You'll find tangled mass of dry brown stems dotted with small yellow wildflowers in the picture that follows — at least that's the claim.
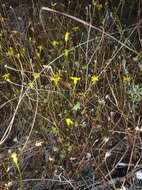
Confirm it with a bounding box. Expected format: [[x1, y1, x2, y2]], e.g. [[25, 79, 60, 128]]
[[0, 0, 142, 189]]
